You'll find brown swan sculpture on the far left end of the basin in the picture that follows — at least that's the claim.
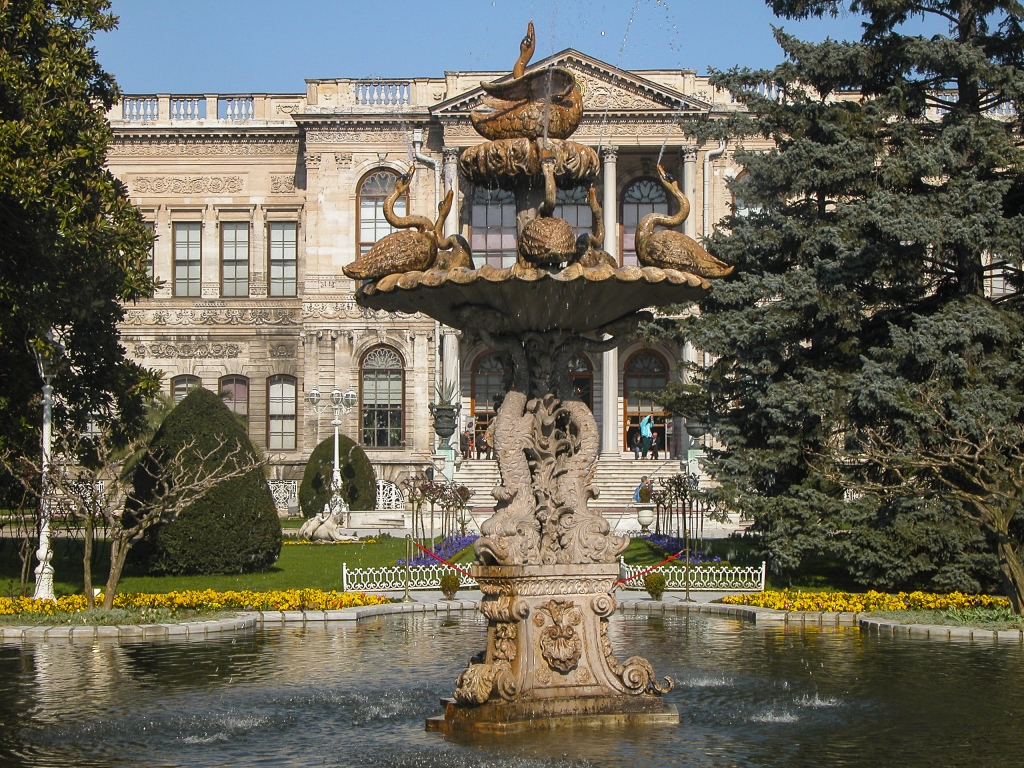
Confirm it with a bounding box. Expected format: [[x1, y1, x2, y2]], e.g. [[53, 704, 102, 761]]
[[341, 164, 437, 280]]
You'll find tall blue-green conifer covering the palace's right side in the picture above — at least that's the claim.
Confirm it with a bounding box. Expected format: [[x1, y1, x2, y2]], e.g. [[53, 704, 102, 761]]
[[664, 0, 1024, 604]]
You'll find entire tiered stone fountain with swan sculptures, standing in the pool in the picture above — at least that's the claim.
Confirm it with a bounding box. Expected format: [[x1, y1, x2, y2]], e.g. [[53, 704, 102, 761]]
[[345, 24, 730, 731]]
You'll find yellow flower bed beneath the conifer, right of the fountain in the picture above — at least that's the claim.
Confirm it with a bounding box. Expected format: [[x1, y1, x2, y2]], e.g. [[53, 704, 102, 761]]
[[722, 590, 1010, 613]]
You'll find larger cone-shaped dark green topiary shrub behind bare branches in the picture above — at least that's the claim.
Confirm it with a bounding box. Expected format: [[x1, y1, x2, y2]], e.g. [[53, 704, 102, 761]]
[[134, 388, 281, 574]]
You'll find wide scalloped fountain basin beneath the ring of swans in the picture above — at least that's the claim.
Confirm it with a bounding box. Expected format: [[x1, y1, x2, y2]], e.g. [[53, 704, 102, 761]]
[[355, 264, 711, 333]]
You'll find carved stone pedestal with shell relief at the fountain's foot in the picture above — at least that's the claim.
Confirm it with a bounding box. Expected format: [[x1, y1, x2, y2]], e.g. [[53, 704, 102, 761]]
[[427, 563, 679, 731]]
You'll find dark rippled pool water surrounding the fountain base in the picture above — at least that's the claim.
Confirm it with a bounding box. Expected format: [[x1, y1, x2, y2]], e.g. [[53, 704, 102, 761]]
[[0, 613, 1024, 768]]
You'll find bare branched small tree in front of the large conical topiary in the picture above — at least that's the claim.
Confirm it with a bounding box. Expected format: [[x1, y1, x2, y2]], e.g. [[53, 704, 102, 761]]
[[0, 429, 264, 610]]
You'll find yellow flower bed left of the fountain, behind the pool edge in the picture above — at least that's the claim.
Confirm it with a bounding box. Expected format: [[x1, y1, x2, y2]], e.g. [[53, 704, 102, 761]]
[[0, 590, 390, 615]]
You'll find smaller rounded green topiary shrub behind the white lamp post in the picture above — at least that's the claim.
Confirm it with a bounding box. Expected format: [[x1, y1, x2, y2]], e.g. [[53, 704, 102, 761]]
[[299, 434, 377, 517]]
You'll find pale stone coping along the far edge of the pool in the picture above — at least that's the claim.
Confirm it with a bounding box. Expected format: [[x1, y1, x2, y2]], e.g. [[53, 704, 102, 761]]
[[0, 599, 1024, 645]]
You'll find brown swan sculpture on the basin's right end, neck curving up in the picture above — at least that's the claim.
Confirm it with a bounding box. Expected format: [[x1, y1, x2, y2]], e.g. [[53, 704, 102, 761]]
[[636, 166, 735, 278]]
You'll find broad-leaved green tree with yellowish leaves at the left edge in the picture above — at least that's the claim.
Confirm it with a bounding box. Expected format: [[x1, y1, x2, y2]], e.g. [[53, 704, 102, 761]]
[[0, 0, 157, 453]]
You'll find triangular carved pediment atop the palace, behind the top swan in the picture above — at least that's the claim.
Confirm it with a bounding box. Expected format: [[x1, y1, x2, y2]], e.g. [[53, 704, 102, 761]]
[[430, 48, 711, 119]]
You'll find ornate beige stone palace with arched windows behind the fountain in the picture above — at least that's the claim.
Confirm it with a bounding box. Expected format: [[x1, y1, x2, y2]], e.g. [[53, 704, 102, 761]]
[[110, 50, 761, 506]]
